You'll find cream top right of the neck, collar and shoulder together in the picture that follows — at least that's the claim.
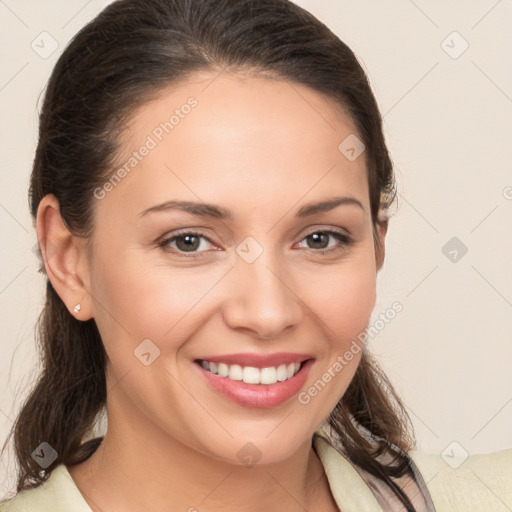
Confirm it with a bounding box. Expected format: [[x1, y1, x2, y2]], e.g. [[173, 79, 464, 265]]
[[313, 431, 512, 512]]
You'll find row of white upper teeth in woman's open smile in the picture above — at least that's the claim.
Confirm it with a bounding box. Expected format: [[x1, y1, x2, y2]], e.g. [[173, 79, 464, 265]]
[[201, 360, 300, 385]]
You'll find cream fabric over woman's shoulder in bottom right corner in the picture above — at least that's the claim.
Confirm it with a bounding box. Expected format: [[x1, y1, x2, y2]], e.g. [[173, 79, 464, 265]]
[[409, 449, 512, 512]]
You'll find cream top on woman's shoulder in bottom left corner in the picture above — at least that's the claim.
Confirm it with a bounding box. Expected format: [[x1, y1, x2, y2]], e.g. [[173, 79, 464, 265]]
[[0, 464, 91, 512]]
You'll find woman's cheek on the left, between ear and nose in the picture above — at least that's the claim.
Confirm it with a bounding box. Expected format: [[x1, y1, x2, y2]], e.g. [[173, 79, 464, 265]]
[[91, 243, 226, 348]]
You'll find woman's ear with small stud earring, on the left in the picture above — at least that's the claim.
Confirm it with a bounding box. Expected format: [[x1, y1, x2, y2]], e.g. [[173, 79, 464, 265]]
[[36, 194, 92, 320]]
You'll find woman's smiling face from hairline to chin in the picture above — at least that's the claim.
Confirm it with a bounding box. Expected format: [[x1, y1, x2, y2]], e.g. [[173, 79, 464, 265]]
[[89, 72, 378, 464]]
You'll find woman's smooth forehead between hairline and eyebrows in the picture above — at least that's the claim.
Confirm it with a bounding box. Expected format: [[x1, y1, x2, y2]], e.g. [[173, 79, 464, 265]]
[[98, 72, 368, 222]]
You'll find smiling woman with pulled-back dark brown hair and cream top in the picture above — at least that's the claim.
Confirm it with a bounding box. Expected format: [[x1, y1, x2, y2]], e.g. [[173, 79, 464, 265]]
[[2, 0, 508, 512]]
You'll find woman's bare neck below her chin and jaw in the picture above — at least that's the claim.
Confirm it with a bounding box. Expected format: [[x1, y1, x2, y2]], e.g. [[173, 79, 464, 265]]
[[69, 394, 332, 512]]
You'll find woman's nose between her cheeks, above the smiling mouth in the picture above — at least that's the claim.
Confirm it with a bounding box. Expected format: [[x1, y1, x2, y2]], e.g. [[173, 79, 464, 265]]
[[223, 253, 303, 340]]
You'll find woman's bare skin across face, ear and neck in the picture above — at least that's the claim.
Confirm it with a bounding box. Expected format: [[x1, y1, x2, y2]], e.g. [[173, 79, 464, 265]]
[[37, 71, 385, 512]]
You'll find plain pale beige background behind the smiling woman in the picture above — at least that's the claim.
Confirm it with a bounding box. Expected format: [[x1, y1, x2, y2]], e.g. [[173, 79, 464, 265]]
[[0, 0, 512, 496]]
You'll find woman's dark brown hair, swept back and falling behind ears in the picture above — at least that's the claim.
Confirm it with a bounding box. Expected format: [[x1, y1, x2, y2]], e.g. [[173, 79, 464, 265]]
[[4, 0, 414, 511]]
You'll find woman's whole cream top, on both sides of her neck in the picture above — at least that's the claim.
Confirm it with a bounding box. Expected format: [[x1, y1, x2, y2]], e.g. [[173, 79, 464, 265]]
[[0, 431, 512, 512]]
